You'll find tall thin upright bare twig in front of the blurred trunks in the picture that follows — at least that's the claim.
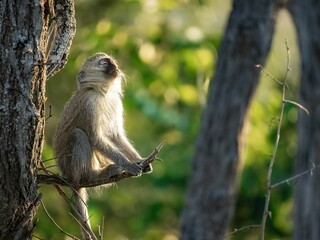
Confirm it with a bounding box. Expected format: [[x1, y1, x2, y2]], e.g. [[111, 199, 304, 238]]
[[260, 39, 290, 240]]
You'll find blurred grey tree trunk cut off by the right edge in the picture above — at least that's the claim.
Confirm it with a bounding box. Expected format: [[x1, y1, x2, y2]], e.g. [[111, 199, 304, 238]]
[[289, 0, 320, 240]]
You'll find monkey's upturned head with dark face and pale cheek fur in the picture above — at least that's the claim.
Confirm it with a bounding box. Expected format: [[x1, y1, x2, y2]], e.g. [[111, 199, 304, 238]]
[[77, 53, 123, 91]]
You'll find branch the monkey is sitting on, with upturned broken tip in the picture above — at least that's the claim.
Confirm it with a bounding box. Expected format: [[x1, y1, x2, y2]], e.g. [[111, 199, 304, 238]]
[[37, 142, 164, 188]]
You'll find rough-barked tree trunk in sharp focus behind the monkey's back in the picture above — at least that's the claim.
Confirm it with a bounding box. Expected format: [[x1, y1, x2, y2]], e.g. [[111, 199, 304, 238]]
[[0, 0, 73, 239]]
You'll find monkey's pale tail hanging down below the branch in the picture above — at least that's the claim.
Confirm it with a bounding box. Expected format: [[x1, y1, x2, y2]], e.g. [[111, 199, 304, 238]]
[[73, 188, 92, 240]]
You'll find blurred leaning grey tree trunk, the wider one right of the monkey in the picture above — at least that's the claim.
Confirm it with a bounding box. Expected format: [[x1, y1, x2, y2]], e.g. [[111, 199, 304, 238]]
[[181, 0, 279, 240]]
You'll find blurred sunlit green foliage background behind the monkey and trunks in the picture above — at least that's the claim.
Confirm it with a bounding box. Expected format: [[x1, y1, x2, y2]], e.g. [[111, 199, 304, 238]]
[[35, 0, 299, 240]]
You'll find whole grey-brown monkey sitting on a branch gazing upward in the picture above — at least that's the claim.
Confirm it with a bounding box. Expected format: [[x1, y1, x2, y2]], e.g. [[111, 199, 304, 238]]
[[53, 53, 152, 239]]
